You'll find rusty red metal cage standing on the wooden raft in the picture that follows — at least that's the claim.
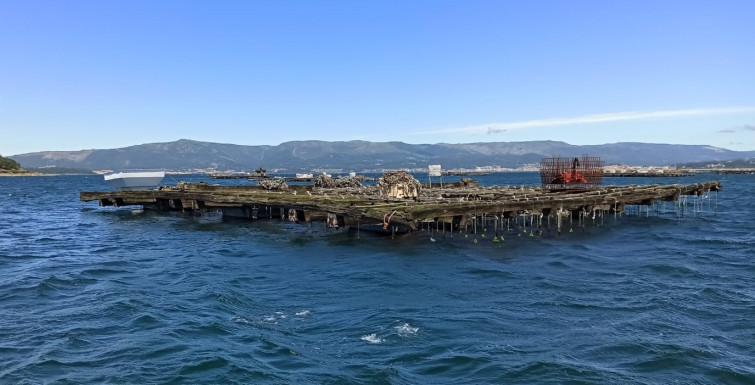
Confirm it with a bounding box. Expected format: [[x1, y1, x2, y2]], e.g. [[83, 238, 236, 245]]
[[540, 155, 603, 189]]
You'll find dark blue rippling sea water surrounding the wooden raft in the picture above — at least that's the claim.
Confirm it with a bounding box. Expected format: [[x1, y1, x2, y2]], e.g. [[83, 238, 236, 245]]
[[0, 173, 755, 384]]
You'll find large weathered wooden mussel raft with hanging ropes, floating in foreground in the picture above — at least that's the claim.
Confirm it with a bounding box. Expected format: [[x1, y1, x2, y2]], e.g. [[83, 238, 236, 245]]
[[80, 181, 722, 231]]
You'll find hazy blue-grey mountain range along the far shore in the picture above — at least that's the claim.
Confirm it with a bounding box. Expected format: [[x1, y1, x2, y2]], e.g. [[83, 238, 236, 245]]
[[10, 139, 755, 172]]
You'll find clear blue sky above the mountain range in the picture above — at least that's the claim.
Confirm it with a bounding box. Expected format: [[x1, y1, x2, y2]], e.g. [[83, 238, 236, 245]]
[[0, 0, 755, 155]]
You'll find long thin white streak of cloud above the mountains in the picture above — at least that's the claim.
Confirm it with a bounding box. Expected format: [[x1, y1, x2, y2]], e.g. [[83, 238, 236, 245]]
[[417, 107, 755, 134]]
